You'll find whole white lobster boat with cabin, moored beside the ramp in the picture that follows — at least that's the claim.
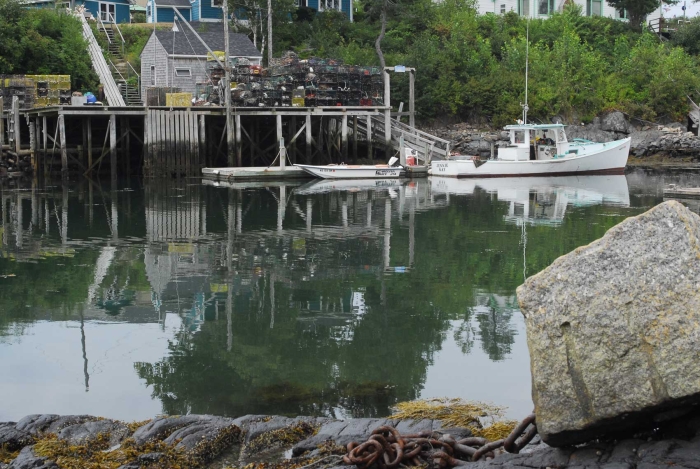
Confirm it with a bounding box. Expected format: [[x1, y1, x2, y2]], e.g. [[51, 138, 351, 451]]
[[429, 124, 631, 178]]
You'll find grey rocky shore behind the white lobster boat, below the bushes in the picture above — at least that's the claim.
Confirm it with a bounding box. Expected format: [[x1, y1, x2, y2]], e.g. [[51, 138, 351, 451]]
[[424, 112, 700, 162]]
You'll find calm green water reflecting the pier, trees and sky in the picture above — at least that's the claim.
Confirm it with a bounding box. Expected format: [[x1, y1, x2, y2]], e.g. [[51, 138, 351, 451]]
[[0, 171, 700, 421]]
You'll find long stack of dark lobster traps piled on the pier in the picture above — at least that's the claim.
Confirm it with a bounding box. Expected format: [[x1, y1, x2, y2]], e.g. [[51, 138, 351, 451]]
[[198, 52, 384, 107]]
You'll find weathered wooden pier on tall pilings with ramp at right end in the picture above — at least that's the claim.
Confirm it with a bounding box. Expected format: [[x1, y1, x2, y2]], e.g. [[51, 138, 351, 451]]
[[0, 98, 449, 178]]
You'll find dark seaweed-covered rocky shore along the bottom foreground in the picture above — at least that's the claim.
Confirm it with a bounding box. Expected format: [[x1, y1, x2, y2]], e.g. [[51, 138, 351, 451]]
[[0, 412, 700, 469]]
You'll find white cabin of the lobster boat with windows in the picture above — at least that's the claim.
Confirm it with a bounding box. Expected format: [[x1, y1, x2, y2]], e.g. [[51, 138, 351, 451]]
[[498, 124, 577, 161]]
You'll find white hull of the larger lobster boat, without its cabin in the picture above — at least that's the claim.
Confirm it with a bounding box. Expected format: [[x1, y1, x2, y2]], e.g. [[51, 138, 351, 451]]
[[430, 138, 631, 178]]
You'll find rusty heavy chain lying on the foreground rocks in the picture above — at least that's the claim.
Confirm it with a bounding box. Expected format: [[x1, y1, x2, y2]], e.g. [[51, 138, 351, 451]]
[[343, 414, 537, 469]]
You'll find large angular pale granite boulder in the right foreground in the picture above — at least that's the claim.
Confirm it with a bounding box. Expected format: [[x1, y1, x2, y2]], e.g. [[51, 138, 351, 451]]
[[517, 202, 700, 444]]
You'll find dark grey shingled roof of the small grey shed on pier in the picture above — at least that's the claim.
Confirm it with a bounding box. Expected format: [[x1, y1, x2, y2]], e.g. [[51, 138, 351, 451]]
[[154, 23, 262, 57]]
